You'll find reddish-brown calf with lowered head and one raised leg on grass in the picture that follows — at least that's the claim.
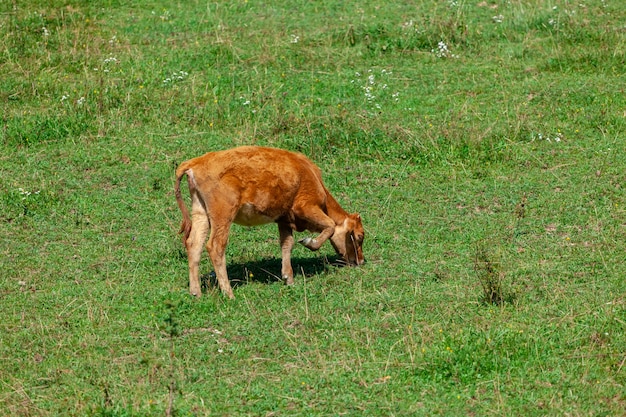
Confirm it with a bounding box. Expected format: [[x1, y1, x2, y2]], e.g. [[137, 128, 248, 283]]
[[174, 146, 365, 298]]
